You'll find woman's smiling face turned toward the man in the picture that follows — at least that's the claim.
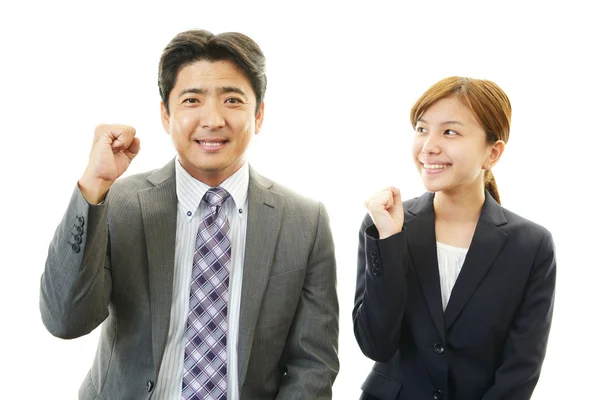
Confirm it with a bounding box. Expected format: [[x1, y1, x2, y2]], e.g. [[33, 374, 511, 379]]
[[412, 97, 503, 193]]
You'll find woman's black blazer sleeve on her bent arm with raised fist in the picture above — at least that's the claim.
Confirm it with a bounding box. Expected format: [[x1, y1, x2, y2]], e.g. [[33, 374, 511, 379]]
[[352, 215, 408, 362]]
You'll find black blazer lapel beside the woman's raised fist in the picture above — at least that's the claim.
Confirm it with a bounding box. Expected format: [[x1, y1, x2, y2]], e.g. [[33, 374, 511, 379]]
[[404, 192, 446, 341]]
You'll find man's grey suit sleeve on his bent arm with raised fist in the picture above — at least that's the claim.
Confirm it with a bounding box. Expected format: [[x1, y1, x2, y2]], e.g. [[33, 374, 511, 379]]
[[40, 186, 112, 339]]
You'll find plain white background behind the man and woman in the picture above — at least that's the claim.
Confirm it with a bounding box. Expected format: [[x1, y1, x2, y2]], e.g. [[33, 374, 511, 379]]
[[0, 0, 600, 400]]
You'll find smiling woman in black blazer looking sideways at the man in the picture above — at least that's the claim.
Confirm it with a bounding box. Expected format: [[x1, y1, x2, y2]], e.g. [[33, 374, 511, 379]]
[[353, 77, 556, 400]]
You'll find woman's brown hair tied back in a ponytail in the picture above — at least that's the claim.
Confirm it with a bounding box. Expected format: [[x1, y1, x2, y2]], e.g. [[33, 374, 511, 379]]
[[410, 76, 512, 204]]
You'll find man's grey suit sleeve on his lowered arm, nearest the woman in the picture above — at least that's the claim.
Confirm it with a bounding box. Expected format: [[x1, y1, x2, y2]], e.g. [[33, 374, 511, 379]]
[[277, 204, 339, 400]]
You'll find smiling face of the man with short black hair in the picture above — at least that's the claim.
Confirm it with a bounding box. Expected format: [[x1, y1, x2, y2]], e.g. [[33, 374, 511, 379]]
[[161, 61, 264, 186]]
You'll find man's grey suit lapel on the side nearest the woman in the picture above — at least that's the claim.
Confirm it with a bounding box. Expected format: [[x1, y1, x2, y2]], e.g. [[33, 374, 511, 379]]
[[238, 168, 283, 386]]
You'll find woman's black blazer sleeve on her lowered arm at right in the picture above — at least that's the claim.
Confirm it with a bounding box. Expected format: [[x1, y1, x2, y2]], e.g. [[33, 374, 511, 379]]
[[483, 232, 556, 400]]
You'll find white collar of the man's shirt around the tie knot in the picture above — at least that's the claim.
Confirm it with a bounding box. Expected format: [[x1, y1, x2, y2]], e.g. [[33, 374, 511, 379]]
[[175, 159, 250, 219]]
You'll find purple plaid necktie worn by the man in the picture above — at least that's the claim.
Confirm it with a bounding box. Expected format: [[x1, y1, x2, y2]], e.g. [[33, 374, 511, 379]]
[[182, 186, 231, 400]]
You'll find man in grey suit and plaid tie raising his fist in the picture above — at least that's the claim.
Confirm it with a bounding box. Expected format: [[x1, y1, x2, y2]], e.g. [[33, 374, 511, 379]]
[[40, 30, 339, 400]]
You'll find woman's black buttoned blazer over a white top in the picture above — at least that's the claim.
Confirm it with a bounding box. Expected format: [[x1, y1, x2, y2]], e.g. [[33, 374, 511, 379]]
[[352, 192, 556, 400]]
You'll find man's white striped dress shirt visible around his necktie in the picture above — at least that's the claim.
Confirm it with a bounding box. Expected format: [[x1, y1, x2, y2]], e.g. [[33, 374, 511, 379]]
[[153, 162, 250, 400]]
